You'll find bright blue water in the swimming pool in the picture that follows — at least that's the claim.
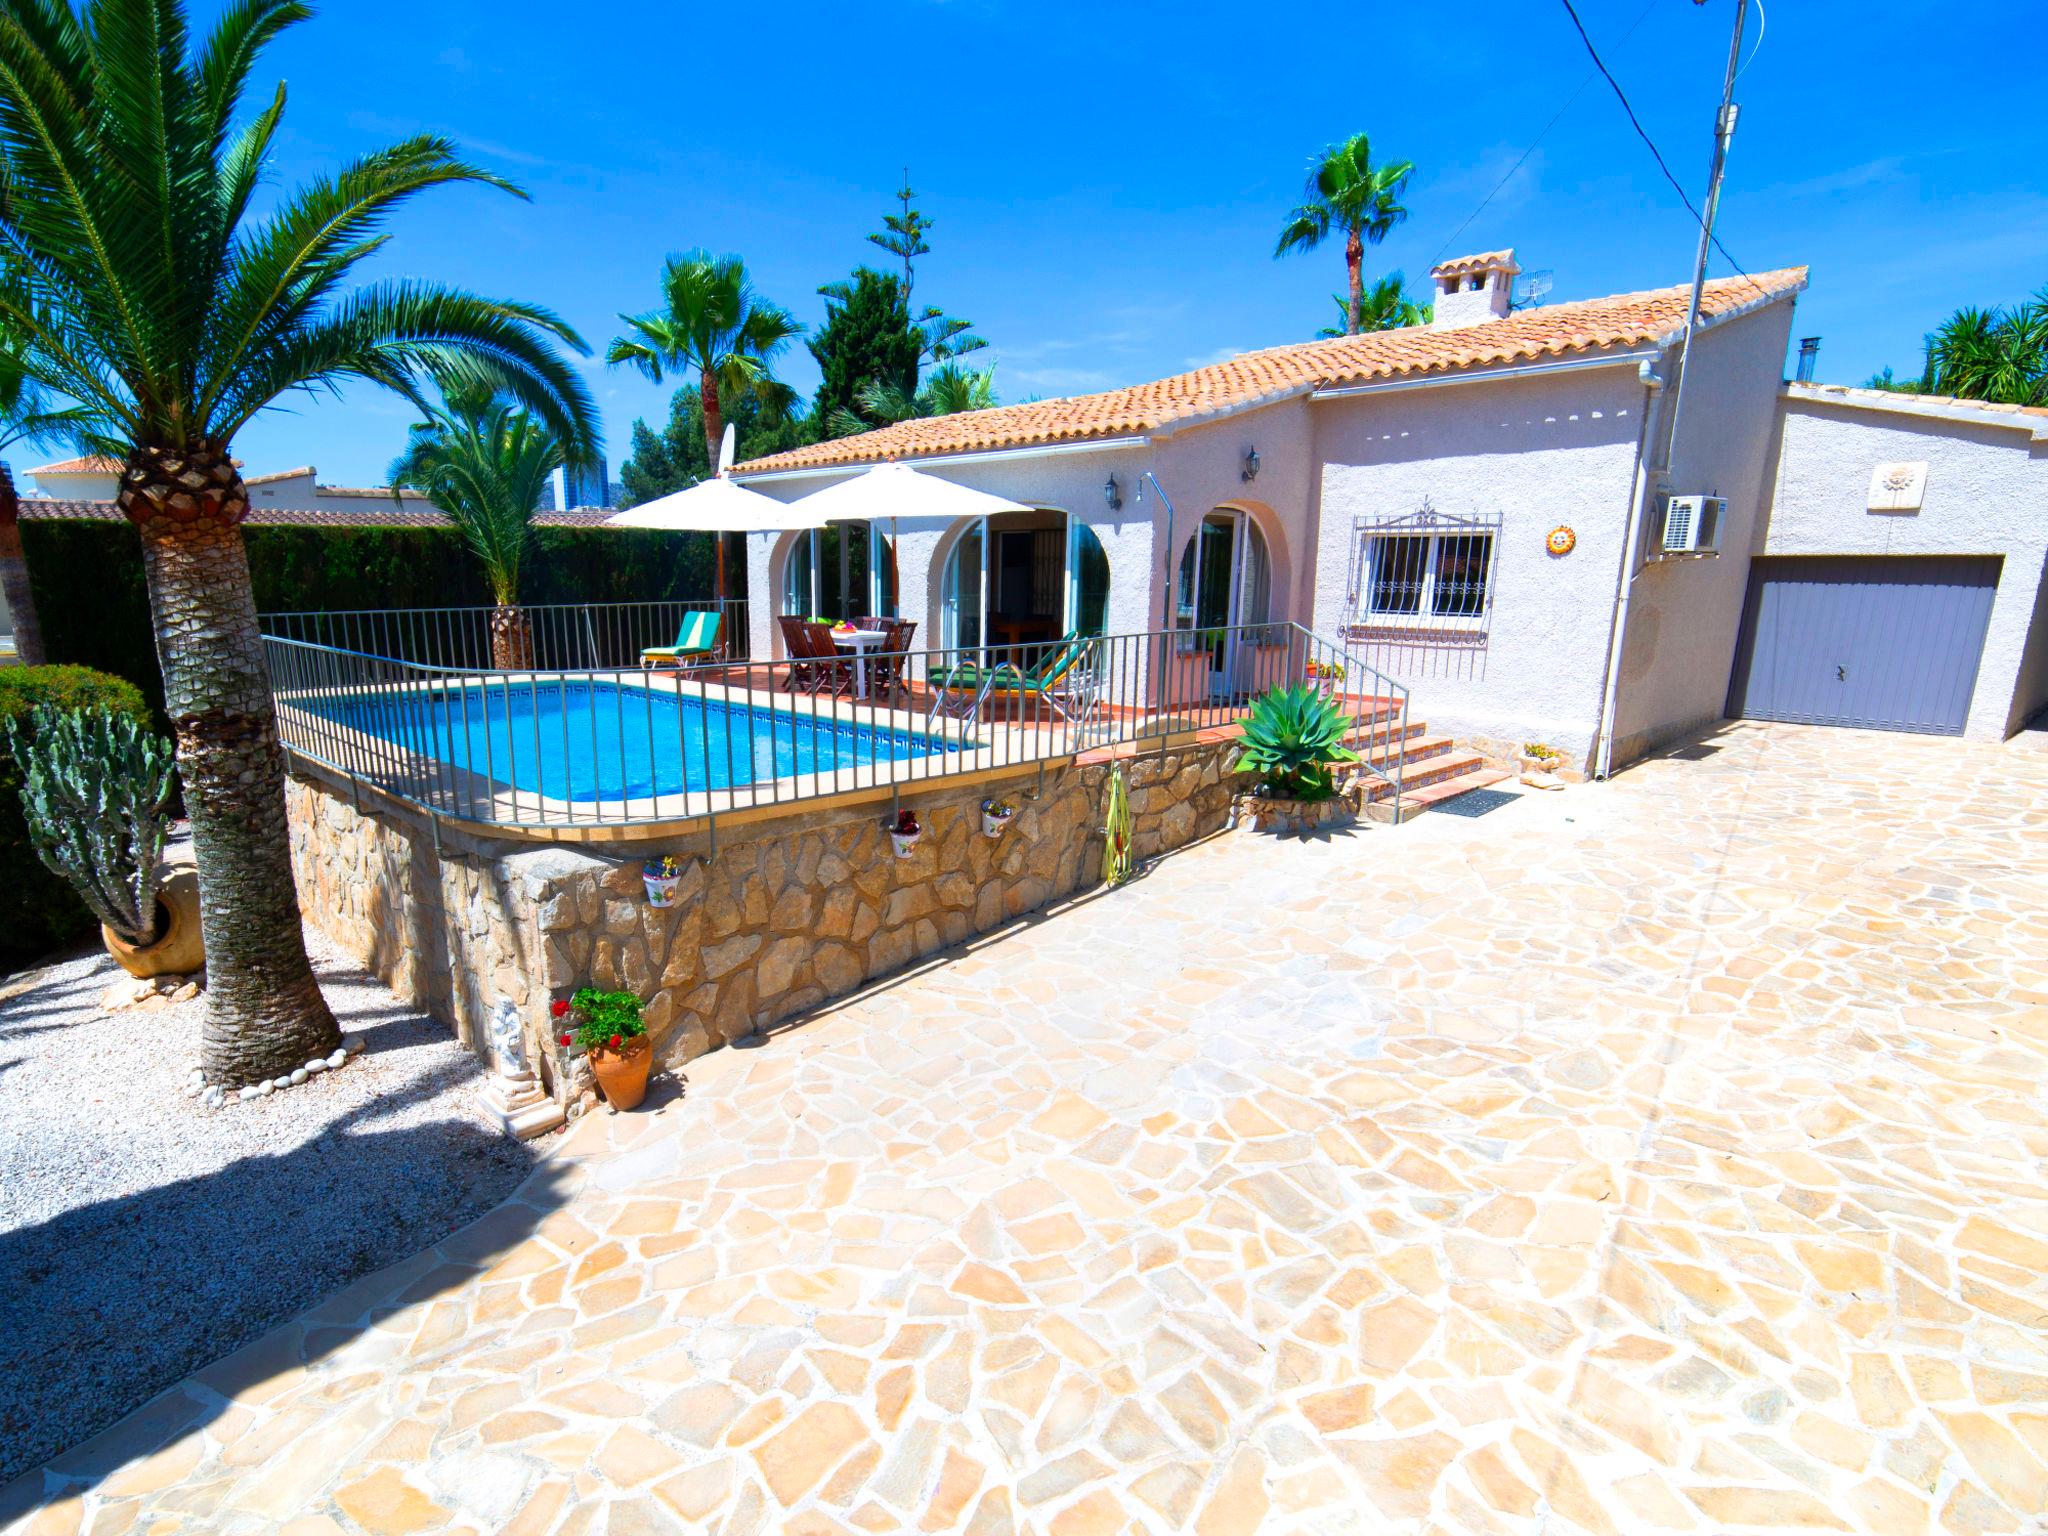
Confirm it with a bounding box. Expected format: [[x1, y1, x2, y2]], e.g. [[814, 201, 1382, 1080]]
[[299, 678, 971, 801]]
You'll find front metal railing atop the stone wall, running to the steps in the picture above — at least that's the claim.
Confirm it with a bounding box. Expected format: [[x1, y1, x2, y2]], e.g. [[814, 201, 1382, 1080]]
[[264, 610, 1407, 829]]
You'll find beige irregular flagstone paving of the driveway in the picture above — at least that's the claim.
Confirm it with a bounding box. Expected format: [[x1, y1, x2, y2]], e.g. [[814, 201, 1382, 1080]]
[[4, 727, 2048, 1536]]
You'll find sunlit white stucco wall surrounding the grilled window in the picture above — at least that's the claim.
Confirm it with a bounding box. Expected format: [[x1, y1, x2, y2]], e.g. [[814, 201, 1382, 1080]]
[[1311, 362, 1647, 760]]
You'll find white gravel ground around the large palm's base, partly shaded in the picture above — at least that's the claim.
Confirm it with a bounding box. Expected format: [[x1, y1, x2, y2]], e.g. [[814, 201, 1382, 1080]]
[[0, 932, 547, 1483]]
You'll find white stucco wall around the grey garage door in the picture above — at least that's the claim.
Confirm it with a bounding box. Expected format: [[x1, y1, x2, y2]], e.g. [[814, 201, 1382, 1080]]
[[1757, 385, 2048, 741]]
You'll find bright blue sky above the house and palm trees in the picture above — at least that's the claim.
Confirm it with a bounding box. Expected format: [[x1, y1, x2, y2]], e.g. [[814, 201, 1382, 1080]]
[[228, 0, 2048, 483]]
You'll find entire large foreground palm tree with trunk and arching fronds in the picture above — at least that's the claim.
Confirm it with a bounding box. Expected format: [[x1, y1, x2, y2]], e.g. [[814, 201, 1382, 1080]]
[[0, 0, 596, 1083]]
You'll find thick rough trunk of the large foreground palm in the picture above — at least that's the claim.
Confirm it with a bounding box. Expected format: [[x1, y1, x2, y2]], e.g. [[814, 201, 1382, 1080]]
[[119, 449, 340, 1085]]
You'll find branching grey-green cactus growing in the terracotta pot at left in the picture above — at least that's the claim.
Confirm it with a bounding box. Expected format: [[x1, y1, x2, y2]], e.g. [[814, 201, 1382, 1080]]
[[6, 705, 176, 944]]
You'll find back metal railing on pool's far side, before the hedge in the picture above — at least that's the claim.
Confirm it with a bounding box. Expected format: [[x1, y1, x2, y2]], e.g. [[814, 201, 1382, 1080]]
[[262, 598, 748, 672]]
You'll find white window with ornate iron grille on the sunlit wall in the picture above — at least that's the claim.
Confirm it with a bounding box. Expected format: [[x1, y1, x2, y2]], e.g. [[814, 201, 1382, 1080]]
[[1352, 502, 1501, 643]]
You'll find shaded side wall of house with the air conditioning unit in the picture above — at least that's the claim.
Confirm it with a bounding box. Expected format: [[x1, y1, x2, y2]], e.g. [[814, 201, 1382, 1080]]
[[1614, 303, 1792, 764]]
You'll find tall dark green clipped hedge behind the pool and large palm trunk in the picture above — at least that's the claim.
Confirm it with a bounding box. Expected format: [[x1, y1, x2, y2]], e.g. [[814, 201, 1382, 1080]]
[[20, 522, 729, 715]]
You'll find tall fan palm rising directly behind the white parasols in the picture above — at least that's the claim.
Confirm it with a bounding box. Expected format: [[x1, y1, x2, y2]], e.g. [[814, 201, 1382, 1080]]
[[604, 250, 803, 598]]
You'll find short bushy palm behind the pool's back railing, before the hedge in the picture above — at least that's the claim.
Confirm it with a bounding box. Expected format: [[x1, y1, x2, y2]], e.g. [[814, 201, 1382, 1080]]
[[391, 387, 569, 672]]
